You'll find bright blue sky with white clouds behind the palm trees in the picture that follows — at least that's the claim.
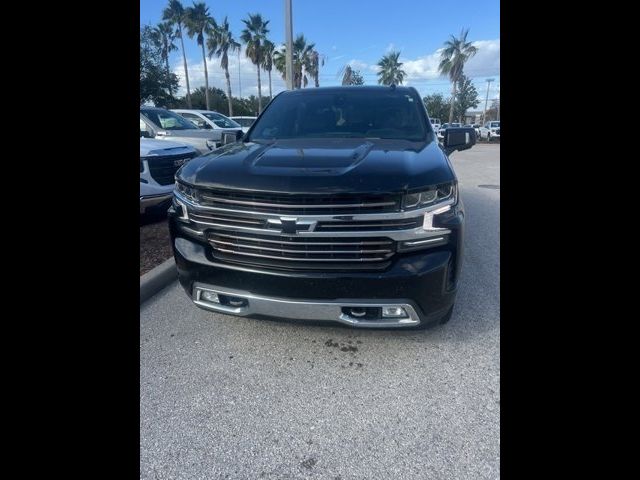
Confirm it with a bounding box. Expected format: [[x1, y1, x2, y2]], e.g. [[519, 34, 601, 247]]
[[140, 0, 500, 109]]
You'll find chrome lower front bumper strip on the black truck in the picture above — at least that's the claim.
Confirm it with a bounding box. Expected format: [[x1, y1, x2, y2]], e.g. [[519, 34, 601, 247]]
[[192, 282, 421, 328]]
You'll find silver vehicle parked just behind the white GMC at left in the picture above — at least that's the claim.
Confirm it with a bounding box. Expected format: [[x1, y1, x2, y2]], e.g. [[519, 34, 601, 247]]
[[140, 107, 222, 154]]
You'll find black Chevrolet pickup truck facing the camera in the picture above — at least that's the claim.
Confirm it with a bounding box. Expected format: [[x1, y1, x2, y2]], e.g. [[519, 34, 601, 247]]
[[169, 86, 476, 328]]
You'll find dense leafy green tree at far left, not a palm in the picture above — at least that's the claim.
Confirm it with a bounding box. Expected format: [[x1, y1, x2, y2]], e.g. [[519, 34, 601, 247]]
[[140, 25, 178, 107]]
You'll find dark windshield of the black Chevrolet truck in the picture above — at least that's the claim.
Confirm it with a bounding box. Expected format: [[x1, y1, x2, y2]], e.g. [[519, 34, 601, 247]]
[[250, 89, 430, 141]]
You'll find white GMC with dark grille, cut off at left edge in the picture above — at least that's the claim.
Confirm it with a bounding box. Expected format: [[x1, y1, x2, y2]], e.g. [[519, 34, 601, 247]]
[[140, 138, 198, 213]]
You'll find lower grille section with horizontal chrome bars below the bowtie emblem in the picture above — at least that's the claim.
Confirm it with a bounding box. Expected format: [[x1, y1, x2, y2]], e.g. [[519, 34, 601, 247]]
[[207, 230, 395, 265]]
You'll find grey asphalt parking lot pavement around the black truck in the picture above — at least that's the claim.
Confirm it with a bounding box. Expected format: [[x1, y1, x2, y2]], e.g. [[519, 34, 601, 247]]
[[140, 144, 500, 480]]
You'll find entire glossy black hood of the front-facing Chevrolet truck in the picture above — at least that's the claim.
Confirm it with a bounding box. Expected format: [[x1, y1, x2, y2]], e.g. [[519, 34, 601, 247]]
[[180, 139, 455, 194]]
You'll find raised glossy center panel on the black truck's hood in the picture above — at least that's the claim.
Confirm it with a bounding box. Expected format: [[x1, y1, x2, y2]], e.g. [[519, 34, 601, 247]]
[[250, 142, 373, 176]]
